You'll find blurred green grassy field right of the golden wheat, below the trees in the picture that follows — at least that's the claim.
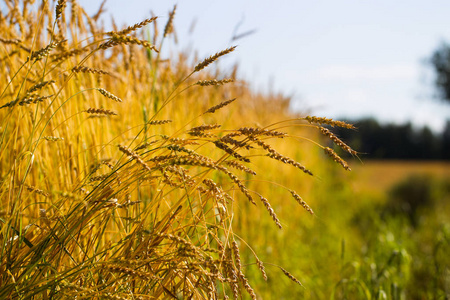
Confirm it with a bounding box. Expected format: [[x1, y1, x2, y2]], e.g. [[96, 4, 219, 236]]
[[229, 160, 450, 299]]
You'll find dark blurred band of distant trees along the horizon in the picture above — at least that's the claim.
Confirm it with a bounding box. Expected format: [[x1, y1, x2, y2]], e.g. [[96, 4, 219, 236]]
[[332, 119, 450, 160]]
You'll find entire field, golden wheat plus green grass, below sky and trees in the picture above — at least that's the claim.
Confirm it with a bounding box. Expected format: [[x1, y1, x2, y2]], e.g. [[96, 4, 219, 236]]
[[0, 0, 450, 299]]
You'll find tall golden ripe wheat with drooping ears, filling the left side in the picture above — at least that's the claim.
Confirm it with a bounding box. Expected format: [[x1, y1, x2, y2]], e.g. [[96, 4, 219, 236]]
[[0, 0, 356, 299]]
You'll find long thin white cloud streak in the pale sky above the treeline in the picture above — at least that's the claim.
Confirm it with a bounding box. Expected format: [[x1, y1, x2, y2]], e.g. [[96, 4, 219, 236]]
[[314, 64, 419, 81]]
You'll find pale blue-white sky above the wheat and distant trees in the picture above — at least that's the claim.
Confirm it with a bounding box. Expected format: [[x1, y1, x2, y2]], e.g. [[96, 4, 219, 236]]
[[79, 0, 450, 131]]
